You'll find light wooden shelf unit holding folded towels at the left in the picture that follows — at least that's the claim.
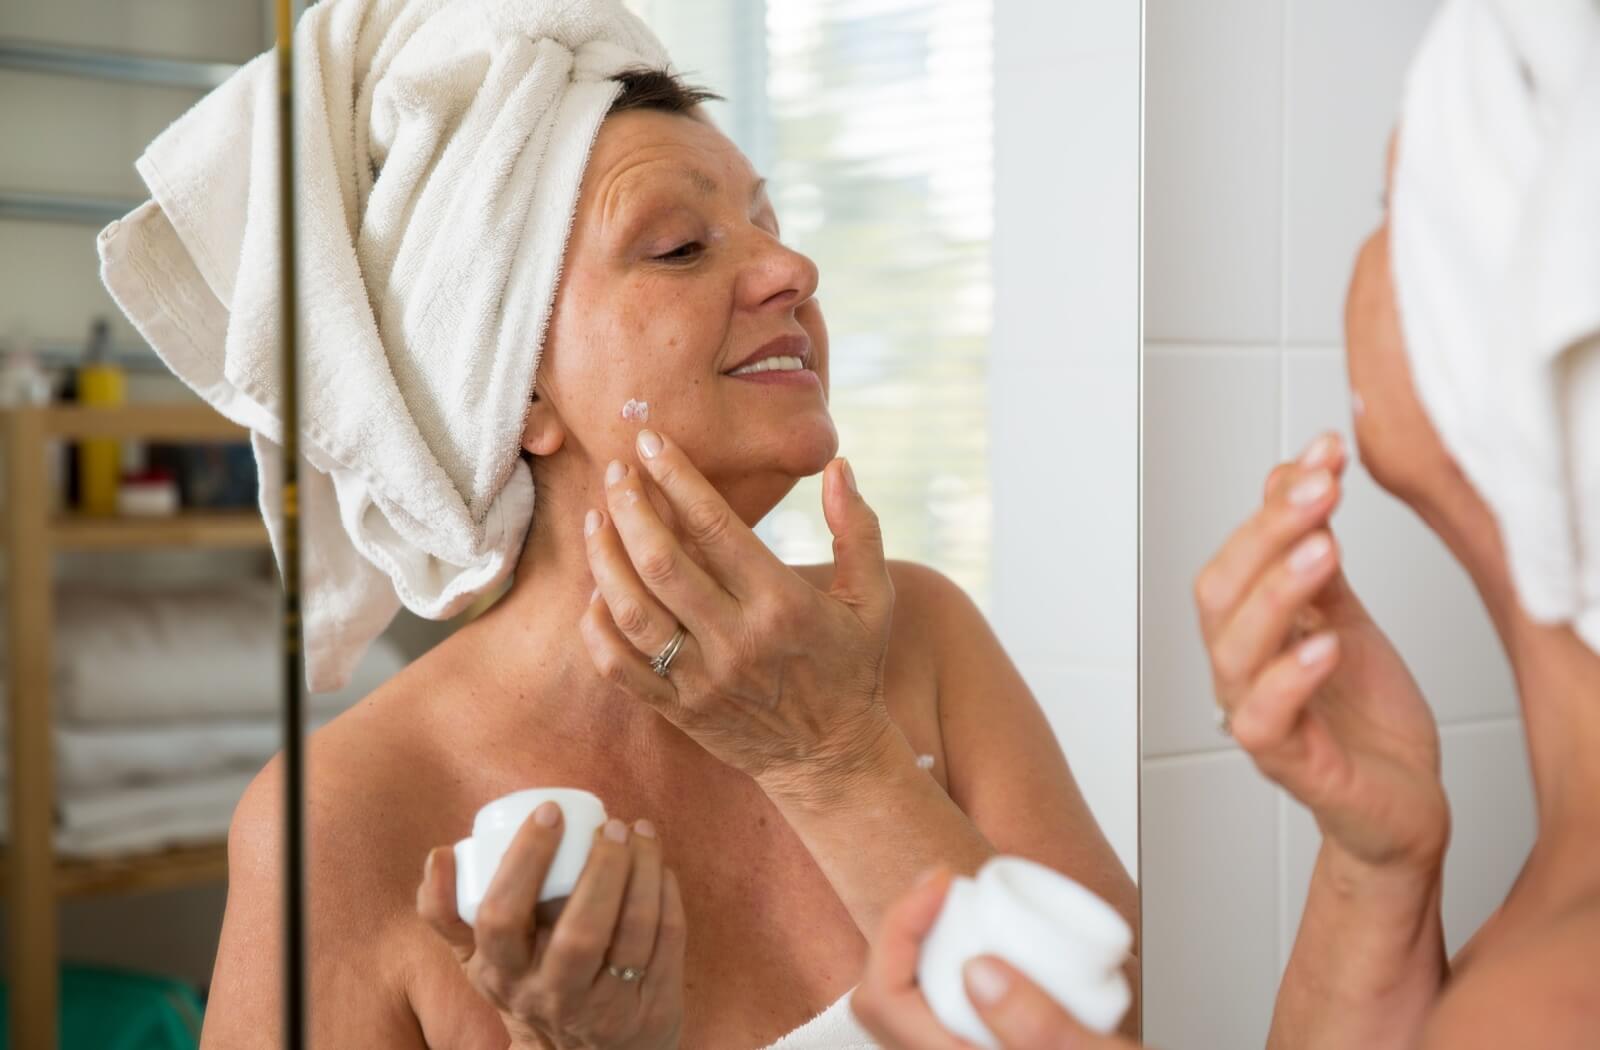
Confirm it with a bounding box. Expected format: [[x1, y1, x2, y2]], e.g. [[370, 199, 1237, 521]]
[[0, 403, 267, 1047]]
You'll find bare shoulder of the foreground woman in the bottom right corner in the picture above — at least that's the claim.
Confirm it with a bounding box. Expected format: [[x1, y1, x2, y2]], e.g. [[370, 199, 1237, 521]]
[[1422, 896, 1600, 1050]]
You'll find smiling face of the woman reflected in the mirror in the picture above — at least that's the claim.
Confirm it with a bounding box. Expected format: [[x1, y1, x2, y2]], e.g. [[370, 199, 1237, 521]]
[[534, 110, 838, 520]]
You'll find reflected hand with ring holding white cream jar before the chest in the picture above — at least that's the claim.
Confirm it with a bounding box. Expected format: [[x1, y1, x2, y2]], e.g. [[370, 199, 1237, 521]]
[[418, 802, 685, 1050]]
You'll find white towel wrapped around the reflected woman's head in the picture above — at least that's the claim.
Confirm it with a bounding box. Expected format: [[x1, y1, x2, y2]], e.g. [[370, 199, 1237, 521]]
[[99, 0, 667, 691]]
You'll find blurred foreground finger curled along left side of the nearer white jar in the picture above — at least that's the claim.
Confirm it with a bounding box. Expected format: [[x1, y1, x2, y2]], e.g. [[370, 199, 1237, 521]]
[[850, 868, 966, 1050]]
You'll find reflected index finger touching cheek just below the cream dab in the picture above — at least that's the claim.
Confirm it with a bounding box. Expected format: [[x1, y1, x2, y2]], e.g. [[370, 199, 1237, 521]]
[[629, 431, 778, 605]]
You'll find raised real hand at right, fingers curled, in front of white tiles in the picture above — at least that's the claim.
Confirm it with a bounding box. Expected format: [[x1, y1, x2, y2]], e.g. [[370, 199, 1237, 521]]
[[1195, 434, 1450, 874]]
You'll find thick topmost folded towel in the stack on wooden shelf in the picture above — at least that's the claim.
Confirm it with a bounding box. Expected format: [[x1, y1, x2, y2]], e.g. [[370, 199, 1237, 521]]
[[3, 581, 406, 727]]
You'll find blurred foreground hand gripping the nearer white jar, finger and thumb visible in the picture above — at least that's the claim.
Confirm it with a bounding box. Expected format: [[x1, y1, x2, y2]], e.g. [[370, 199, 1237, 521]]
[[850, 871, 1134, 1050]]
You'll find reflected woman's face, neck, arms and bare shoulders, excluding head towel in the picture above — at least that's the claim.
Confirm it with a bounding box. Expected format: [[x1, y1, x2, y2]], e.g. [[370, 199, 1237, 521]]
[[152, 8, 1133, 1050]]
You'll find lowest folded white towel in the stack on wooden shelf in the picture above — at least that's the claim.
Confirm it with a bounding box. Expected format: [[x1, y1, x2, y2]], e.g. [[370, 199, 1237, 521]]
[[0, 773, 254, 856]]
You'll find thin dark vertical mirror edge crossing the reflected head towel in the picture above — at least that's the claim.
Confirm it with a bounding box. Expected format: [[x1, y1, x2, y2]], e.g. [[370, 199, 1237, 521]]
[[268, 0, 307, 1050]]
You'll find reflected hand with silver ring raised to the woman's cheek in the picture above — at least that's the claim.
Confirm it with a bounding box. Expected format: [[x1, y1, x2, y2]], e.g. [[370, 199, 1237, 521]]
[[582, 431, 894, 802]]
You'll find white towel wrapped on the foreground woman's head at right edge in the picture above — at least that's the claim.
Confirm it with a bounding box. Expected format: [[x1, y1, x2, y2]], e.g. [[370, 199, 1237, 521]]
[[1390, 0, 1600, 650]]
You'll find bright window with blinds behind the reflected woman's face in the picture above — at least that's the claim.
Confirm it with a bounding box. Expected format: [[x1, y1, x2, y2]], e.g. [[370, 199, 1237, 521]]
[[629, 0, 994, 603]]
